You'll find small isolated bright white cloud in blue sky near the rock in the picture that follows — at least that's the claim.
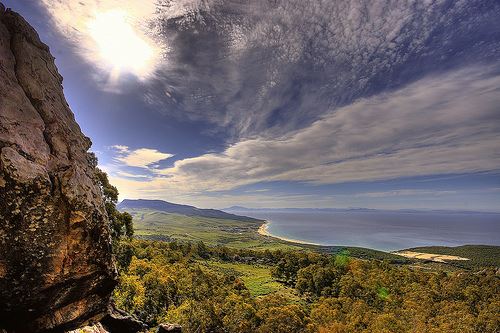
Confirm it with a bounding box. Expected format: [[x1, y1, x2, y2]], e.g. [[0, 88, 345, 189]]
[[112, 145, 174, 167]]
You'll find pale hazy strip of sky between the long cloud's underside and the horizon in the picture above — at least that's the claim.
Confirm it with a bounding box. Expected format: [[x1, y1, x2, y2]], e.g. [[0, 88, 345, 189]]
[[100, 177, 498, 211]]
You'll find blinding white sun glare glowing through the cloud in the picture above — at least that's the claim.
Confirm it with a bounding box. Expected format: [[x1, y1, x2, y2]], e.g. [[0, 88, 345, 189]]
[[88, 10, 156, 77]]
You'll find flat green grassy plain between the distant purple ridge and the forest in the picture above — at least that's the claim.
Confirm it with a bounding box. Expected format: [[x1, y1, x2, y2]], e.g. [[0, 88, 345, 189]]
[[127, 209, 300, 250]]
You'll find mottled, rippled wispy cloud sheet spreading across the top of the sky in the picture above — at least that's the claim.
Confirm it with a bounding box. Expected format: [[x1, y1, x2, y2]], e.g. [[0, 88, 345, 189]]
[[42, 0, 500, 135]]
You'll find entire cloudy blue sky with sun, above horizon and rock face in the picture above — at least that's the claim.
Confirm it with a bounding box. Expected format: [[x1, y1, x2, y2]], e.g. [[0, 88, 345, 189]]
[[3, 0, 500, 211]]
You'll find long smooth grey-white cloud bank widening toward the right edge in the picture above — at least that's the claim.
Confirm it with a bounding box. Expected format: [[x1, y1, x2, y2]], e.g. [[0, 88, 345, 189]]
[[108, 68, 500, 196]]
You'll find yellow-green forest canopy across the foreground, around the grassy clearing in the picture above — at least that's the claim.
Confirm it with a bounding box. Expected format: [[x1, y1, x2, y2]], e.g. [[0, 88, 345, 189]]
[[114, 240, 500, 333]]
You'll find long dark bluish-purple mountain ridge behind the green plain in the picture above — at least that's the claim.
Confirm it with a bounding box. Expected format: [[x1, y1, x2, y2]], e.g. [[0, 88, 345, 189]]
[[117, 199, 261, 222]]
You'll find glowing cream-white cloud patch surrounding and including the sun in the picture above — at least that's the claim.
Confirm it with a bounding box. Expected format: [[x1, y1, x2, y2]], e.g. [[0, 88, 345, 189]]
[[41, 0, 218, 81]]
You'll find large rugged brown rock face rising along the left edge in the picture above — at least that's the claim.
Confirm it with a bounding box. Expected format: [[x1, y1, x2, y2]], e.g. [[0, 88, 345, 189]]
[[0, 6, 116, 333]]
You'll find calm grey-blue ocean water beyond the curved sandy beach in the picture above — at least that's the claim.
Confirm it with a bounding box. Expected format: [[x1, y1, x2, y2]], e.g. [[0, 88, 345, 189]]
[[233, 210, 500, 251]]
